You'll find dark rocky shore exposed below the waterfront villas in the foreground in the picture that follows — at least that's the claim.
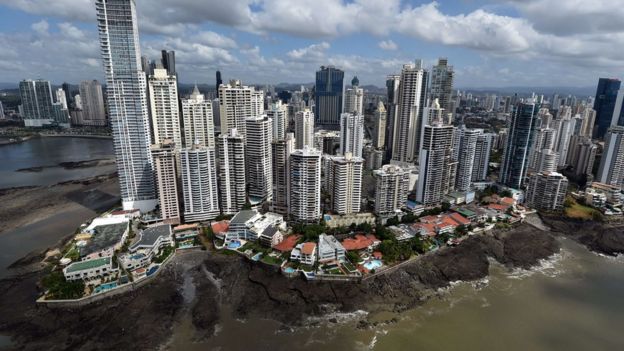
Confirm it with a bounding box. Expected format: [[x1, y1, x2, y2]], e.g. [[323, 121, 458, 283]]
[[0, 224, 559, 350]]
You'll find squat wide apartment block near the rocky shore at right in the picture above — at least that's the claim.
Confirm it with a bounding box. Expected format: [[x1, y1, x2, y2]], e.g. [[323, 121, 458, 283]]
[[526, 172, 568, 211]]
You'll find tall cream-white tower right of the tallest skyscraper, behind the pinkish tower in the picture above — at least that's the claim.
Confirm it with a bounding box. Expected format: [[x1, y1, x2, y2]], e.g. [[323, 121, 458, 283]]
[[147, 68, 182, 148]]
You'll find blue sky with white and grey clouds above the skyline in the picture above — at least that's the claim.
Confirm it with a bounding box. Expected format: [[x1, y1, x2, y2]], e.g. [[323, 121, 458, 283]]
[[0, 0, 624, 88]]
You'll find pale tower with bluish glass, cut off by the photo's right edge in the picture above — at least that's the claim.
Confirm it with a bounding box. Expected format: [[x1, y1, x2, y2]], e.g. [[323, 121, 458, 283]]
[[596, 126, 624, 188]]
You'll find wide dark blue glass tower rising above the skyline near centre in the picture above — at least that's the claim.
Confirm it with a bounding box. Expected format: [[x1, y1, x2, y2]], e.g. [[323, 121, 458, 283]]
[[314, 66, 344, 127]]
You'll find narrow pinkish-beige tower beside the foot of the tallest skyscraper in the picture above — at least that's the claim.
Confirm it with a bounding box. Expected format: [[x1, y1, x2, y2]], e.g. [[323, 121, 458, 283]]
[[151, 139, 180, 224]]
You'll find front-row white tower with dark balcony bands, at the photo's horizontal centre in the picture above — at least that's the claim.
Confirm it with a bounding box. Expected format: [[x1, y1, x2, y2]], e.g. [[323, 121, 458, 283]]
[[288, 146, 321, 223]]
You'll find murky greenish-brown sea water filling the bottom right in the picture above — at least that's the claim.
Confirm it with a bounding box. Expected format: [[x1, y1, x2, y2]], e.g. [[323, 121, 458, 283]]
[[169, 239, 624, 351]]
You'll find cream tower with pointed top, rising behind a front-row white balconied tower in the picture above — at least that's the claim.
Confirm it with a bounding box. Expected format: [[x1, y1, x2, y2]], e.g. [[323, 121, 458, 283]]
[[182, 85, 215, 149]]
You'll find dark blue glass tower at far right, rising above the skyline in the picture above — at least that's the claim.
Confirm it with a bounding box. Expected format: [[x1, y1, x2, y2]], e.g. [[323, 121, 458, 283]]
[[594, 78, 621, 139]]
